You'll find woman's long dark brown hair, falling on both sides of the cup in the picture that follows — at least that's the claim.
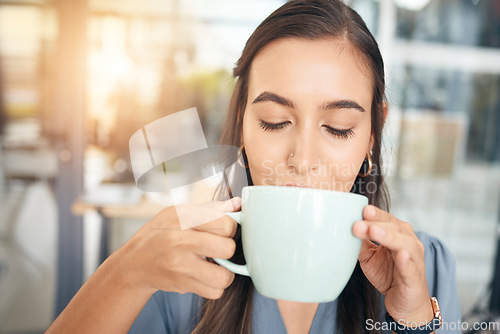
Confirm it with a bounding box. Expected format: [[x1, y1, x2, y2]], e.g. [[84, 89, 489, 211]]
[[193, 0, 389, 334]]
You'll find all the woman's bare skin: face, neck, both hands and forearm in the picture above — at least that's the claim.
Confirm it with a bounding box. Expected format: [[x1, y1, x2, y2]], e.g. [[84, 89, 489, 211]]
[[47, 39, 432, 333]]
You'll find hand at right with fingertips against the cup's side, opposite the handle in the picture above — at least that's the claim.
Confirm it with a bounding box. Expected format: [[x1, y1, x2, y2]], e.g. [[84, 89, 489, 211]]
[[352, 205, 433, 325]]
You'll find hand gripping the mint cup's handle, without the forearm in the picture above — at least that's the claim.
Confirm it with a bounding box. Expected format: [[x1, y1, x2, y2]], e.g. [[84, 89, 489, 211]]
[[108, 197, 241, 299]]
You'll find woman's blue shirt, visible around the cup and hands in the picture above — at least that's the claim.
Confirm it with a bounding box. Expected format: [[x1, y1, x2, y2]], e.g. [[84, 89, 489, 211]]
[[129, 232, 461, 334]]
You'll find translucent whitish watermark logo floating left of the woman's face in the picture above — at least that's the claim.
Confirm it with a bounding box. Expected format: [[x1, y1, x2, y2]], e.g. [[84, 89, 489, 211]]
[[129, 108, 248, 229]]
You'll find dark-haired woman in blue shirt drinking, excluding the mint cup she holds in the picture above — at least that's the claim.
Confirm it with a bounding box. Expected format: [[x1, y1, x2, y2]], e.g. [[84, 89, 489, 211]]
[[49, 0, 460, 333]]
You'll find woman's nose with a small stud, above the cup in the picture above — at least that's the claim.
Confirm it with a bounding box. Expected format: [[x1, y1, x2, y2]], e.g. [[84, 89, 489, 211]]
[[288, 125, 321, 176]]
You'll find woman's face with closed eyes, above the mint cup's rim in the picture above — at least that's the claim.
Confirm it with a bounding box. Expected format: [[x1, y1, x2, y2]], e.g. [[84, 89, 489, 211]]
[[242, 38, 373, 191]]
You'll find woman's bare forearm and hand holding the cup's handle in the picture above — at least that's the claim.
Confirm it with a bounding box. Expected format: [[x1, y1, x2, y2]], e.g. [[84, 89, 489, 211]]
[[46, 198, 241, 334]]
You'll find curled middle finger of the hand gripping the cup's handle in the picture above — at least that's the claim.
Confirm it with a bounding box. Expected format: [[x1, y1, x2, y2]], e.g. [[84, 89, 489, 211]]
[[189, 232, 236, 259]]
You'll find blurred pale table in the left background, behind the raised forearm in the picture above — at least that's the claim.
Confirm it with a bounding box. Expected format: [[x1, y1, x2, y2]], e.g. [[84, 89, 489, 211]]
[[71, 184, 168, 264]]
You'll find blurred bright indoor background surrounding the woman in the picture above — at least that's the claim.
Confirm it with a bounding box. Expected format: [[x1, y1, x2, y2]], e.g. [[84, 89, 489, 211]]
[[0, 0, 500, 333]]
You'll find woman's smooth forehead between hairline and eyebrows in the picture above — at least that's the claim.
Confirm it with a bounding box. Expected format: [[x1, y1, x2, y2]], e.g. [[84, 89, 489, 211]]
[[249, 38, 373, 99]]
